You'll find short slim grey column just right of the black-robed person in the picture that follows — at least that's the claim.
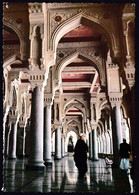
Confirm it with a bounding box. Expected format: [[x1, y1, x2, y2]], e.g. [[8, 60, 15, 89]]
[[92, 129, 98, 161]]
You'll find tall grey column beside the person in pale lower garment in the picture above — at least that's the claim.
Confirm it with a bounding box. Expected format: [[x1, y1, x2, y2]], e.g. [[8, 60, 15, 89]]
[[112, 105, 122, 167]]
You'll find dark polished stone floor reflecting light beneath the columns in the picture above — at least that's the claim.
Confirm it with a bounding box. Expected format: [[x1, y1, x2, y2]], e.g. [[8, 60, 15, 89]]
[[1, 156, 135, 193]]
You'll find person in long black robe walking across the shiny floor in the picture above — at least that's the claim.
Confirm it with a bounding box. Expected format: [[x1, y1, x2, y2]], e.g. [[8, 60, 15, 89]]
[[74, 133, 88, 179]]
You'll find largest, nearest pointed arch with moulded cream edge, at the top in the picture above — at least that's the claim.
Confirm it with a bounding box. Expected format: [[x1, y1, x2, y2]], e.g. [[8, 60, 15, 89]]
[[50, 13, 117, 54]]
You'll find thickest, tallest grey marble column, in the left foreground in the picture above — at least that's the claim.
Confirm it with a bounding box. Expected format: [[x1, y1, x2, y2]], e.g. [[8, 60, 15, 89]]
[[26, 86, 45, 170]]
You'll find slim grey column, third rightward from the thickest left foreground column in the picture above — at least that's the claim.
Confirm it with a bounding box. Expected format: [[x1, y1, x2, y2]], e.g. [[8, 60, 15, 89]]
[[55, 127, 61, 160]]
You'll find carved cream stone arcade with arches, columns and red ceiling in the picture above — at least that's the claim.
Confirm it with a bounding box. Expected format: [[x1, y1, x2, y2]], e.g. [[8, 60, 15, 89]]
[[3, 3, 135, 172]]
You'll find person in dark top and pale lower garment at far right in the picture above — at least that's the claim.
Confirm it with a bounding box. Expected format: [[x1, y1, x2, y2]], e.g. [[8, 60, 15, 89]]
[[120, 138, 131, 173]]
